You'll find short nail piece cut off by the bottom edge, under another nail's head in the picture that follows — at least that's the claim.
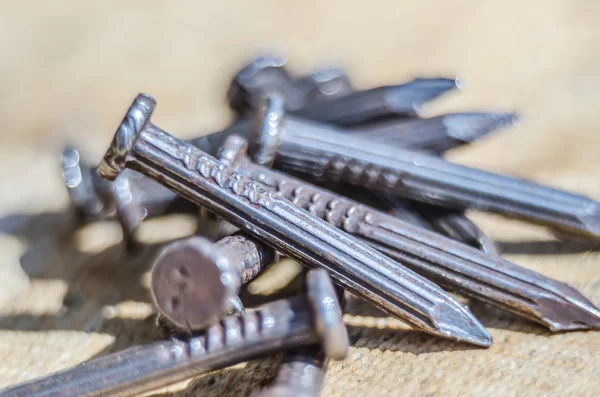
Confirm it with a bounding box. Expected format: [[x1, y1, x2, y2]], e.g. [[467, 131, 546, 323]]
[[254, 346, 327, 397]]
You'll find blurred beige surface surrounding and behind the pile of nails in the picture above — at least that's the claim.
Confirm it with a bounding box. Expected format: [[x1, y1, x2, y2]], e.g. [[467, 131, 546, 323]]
[[0, 0, 600, 397]]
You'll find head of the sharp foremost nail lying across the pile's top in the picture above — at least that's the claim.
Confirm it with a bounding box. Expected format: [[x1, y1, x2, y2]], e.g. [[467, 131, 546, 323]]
[[98, 94, 156, 181]]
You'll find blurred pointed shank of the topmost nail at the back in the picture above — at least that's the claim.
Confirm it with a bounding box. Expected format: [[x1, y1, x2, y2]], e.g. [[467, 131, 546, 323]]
[[294, 78, 459, 126]]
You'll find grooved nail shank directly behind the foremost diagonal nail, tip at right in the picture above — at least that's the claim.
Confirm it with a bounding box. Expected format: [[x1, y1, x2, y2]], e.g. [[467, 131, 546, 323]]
[[223, 137, 600, 331]]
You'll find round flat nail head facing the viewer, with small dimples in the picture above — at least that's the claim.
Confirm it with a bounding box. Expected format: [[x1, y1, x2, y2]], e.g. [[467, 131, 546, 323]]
[[151, 236, 239, 330]]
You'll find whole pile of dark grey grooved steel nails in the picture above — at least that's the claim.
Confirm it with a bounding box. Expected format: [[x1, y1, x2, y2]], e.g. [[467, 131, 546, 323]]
[[1, 56, 600, 397]]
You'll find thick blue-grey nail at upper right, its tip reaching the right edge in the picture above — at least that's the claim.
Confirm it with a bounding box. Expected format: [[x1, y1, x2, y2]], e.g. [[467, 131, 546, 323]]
[[251, 96, 600, 238]]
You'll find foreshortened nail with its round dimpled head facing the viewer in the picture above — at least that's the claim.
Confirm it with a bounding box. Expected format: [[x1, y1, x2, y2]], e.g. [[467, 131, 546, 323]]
[[151, 230, 276, 330]]
